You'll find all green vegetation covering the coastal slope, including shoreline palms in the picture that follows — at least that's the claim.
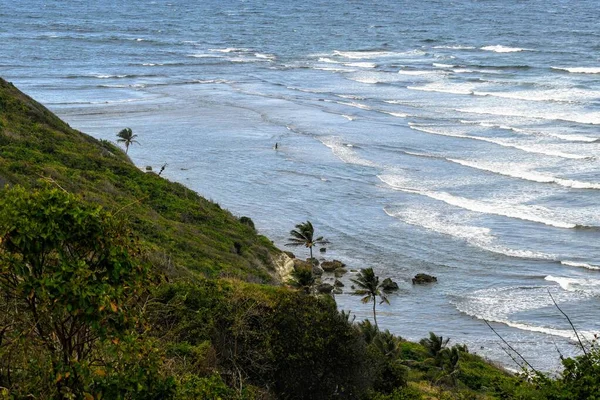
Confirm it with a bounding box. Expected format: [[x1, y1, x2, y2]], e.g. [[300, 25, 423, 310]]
[[0, 80, 600, 400]]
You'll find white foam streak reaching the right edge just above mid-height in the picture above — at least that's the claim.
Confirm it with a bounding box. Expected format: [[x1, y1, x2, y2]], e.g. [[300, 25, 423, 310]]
[[447, 158, 600, 189]]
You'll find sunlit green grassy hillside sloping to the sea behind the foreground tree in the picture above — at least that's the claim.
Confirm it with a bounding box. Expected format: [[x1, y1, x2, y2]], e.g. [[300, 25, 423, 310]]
[[0, 78, 278, 283]]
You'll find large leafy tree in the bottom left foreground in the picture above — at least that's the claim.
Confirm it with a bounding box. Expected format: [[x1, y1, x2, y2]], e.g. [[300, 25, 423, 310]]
[[0, 187, 171, 398]]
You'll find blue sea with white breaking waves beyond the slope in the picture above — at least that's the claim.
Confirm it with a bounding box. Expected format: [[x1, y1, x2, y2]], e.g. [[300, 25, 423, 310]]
[[0, 0, 600, 369]]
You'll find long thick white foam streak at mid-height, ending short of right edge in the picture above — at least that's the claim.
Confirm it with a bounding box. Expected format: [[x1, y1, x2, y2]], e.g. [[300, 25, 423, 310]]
[[377, 175, 577, 229]]
